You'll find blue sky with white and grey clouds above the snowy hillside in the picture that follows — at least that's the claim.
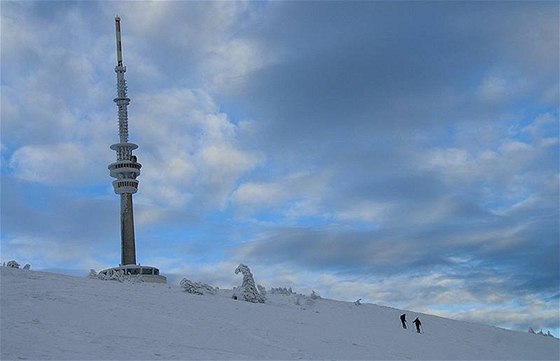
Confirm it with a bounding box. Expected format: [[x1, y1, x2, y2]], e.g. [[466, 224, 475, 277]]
[[1, 1, 560, 336]]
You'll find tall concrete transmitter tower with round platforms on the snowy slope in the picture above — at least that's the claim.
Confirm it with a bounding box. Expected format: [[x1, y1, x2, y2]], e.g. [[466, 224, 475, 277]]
[[100, 16, 166, 282]]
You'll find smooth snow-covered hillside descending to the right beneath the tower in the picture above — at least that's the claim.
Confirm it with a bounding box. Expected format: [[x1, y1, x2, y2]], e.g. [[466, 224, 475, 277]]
[[0, 267, 560, 360]]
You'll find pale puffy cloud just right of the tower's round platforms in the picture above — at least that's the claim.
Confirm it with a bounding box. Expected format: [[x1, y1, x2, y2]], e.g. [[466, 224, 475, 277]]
[[130, 88, 261, 209]]
